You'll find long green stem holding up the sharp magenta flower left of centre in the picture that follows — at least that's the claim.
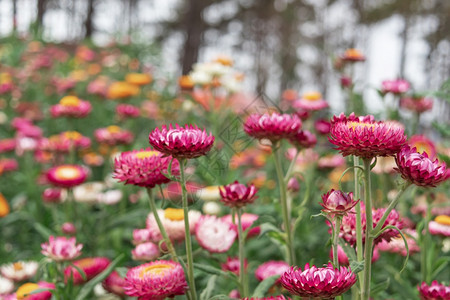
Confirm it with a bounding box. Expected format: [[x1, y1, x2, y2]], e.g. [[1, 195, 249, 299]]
[[178, 159, 197, 300]]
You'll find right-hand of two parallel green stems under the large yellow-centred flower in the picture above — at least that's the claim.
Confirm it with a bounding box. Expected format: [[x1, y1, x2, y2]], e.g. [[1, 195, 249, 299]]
[[361, 158, 374, 300]]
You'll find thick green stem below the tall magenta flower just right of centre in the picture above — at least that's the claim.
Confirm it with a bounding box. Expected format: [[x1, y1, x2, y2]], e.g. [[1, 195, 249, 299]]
[[272, 143, 295, 266]]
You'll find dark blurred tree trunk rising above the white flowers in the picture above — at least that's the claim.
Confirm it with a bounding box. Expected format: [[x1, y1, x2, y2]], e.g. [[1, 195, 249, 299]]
[[182, 0, 208, 74]]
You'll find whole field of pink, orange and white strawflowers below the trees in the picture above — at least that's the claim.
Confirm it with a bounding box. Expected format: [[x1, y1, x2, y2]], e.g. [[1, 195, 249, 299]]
[[0, 38, 450, 300]]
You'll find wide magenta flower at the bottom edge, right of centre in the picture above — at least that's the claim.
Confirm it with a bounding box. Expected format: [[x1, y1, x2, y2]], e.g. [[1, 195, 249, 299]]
[[281, 263, 356, 299]]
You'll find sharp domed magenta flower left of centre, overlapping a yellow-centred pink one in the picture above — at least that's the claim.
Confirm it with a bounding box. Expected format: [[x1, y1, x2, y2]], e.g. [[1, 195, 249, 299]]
[[149, 124, 215, 159]]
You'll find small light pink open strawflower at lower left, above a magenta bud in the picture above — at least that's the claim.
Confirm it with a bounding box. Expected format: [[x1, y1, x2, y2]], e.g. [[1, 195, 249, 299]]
[[41, 236, 83, 262]]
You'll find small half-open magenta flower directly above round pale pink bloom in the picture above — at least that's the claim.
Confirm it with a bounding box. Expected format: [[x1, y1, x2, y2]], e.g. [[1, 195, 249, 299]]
[[219, 180, 258, 208]]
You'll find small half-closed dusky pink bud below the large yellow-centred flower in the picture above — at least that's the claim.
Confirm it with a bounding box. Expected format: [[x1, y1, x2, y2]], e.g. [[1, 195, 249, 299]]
[[319, 189, 359, 218]]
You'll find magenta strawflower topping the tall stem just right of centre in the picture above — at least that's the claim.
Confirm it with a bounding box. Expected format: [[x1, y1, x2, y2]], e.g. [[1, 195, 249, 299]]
[[244, 112, 302, 142]]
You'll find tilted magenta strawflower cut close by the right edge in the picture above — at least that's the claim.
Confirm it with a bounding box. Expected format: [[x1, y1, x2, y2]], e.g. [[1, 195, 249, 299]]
[[395, 146, 449, 187]]
